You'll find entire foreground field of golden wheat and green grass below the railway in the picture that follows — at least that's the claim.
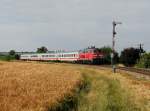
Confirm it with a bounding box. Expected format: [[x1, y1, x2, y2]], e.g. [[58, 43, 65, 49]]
[[0, 61, 150, 111]]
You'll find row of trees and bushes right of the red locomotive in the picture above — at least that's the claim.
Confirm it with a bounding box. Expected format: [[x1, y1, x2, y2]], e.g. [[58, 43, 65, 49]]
[[99, 47, 150, 68]]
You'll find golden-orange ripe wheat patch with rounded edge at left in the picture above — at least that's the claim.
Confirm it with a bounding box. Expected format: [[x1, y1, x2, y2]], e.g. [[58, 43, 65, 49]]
[[0, 62, 81, 111]]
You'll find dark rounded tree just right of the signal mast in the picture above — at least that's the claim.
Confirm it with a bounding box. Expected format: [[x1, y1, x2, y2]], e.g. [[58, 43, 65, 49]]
[[120, 47, 140, 66]]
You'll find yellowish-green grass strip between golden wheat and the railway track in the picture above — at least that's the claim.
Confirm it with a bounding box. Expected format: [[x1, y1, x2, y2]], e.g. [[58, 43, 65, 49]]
[[77, 70, 145, 111]]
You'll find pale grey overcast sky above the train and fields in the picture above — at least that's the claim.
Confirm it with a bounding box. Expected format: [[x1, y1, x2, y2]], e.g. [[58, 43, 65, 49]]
[[0, 0, 150, 52]]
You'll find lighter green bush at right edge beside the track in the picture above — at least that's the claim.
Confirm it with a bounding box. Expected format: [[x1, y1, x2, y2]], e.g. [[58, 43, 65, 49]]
[[137, 53, 150, 68]]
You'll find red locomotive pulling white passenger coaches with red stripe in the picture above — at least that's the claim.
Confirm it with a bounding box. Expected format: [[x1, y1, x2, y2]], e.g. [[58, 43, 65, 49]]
[[20, 48, 104, 64]]
